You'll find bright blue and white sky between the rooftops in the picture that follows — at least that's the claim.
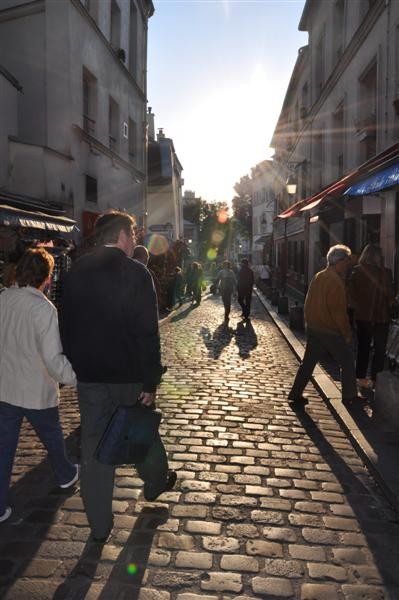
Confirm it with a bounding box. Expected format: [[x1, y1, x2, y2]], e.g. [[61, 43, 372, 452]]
[[148, 0, 307, 202]]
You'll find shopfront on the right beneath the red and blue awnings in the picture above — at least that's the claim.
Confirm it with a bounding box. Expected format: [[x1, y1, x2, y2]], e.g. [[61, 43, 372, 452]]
[[275, 144, 399, 291]]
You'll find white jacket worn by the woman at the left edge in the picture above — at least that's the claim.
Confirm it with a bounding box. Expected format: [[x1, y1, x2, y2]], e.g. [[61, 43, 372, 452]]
[[0, 286, 76, 409]]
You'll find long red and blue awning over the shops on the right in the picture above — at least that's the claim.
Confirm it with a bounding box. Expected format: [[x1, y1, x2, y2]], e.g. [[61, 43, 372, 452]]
[[277, 144, 399, 219]]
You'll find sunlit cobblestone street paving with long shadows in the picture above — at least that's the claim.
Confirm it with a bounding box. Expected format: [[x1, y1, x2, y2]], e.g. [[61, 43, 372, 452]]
[[0, 297, 399, 600]]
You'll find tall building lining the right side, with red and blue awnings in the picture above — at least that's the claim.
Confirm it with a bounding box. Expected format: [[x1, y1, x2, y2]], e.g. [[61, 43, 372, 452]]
[[271, 0, 399, 295]]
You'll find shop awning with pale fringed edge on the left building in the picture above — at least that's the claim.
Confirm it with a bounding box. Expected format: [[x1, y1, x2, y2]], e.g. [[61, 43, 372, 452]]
[[0, 204, 76, 233]]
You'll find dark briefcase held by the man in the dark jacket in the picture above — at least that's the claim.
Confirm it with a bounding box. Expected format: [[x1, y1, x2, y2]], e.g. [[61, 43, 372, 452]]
[[94, 404, 162, 466]]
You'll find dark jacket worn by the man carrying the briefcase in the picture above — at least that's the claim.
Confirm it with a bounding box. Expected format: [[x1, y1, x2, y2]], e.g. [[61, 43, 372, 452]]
[[60, 247, 163, 392]]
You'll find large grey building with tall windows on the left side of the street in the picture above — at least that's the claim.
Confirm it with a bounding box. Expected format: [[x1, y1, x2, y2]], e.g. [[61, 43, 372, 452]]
[[0, 0, 154, 234]]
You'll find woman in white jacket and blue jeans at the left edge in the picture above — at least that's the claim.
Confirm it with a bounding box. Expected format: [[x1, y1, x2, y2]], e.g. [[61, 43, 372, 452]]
[[0, 248, 79, 523]]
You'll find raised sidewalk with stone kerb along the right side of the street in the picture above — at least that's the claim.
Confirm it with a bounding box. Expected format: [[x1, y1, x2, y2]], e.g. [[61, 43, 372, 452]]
[[255, 288, 399, 512]]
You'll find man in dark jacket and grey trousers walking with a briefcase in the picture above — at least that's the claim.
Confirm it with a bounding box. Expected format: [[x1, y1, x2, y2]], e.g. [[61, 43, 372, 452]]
[[61, 212, 176, 542]]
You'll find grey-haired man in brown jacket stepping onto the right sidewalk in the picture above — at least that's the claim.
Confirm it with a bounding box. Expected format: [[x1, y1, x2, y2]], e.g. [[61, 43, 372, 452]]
[[288, 245, 359, 405]]
